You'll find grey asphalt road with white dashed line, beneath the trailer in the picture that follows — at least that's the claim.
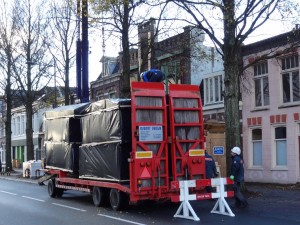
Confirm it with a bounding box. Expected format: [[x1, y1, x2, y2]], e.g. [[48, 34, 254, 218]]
[[0, 174, 300, 225]]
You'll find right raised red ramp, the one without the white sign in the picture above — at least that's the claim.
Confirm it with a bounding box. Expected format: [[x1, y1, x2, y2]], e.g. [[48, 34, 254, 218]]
[[169, 84, 205, 181]]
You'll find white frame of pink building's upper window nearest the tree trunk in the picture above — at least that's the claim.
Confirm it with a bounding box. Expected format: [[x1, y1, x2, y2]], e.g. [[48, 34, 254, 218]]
[[253, 61, 270, 108]]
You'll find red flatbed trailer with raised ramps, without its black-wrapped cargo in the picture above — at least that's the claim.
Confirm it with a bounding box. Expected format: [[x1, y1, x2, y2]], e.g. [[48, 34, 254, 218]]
[[42, 82, 208, 210]]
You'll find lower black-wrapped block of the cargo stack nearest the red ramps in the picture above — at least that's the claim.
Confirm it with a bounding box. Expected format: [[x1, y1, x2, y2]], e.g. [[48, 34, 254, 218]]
[[79, 142, 131, 181]]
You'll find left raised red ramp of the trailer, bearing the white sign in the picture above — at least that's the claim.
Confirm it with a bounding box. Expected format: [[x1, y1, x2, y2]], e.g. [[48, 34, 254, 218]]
[[130, 82, 169, 202]]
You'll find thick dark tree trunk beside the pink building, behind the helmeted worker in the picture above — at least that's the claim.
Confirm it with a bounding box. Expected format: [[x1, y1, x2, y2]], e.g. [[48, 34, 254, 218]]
[[223, 0, 241, 175]]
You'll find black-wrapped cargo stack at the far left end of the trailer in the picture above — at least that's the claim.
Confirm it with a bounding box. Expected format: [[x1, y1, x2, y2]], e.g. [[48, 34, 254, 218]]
[[45, 103, 90, 175]]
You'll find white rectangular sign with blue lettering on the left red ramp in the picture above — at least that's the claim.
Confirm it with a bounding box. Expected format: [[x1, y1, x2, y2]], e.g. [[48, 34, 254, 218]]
[[139, 126, 163, 141]]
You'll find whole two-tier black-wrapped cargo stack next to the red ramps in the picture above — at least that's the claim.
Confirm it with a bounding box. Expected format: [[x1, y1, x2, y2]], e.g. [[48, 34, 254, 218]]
[[79, 99, 132, 182]]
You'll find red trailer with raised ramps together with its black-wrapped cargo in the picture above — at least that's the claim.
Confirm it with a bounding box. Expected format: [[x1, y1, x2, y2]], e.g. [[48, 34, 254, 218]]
[[44, 82, 210, 210]]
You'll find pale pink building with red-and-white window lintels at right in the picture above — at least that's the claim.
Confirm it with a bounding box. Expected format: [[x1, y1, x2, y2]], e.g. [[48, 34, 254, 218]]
[[242, 29, 300, 184]]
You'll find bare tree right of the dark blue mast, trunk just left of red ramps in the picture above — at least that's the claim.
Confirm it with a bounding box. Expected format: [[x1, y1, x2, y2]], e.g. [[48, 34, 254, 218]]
[[90, 0, 182, 97]]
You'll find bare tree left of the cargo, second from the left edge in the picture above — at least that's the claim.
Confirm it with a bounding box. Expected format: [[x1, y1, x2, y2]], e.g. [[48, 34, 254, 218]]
[[14, 0, 51, 160]]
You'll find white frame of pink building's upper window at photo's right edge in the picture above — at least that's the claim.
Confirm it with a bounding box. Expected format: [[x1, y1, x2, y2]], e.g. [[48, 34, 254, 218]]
[[281, 55, 300, 104]]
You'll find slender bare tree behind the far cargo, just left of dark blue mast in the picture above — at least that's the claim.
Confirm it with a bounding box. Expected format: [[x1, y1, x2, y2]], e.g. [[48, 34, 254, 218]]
[[50, 0, 77, 105]]
